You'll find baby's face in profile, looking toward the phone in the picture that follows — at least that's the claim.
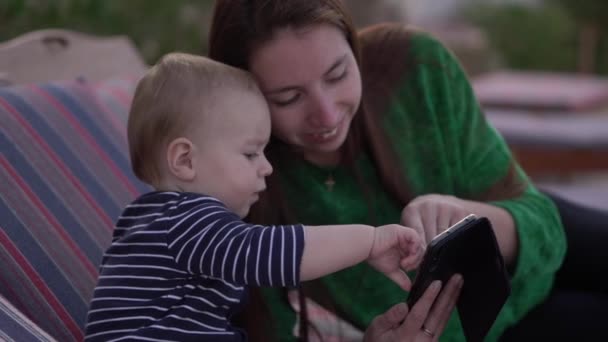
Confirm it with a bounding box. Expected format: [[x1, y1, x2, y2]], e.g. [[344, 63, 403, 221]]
[[192, 91, 272, 217]]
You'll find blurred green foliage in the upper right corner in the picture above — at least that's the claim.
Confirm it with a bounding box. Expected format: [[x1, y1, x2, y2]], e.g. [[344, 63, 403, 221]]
[[466, 0, 608, 74]]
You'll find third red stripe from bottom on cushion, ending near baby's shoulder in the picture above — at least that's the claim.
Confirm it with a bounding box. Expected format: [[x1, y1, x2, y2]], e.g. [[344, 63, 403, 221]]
[[0, 98, 114, 230]]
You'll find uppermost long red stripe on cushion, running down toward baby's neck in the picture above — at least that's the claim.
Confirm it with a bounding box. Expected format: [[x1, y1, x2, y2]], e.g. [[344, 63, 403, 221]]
[[30, 85, 139, 199]]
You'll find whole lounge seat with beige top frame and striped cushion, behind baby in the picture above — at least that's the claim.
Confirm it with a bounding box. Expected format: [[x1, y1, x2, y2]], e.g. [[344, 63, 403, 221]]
[[0, 29, 148, 341]]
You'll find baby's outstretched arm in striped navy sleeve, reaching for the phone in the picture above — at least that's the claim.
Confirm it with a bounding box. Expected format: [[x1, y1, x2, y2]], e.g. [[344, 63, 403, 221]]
[[167, 199, 421, 288]]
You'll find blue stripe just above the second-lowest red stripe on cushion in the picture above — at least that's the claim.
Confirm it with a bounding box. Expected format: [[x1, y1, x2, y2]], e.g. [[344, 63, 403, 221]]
[[0, 131, 105, 265]]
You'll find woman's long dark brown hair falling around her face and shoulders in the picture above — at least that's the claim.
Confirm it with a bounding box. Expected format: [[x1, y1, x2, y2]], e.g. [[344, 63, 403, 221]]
[[209, 0, 524, 341]]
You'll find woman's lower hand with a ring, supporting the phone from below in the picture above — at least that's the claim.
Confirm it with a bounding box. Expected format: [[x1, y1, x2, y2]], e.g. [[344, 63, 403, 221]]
[[363, 275, 463, 342]]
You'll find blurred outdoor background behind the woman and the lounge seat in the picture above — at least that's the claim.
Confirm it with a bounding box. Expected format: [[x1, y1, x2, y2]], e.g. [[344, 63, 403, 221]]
[[0, 0, 608, 208]]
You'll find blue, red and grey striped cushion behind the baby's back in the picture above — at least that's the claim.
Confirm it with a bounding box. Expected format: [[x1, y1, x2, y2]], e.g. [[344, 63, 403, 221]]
[[0, 79, 147, 341]]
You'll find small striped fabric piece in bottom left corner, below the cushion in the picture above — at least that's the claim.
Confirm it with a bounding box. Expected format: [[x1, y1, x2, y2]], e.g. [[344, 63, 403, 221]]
[[0, 297, 55, 342]]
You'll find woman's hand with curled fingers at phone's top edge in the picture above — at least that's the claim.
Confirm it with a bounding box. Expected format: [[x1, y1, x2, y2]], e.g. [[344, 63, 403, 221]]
[[401, 194, 471, 245]]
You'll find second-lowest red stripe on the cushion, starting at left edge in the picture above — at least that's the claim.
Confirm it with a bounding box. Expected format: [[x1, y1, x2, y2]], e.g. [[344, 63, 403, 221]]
[[0, 156, 98, 279]]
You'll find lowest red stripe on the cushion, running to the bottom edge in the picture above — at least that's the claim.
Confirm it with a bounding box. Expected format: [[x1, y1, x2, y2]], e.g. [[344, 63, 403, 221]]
[[0, 230, 84, 341]]
